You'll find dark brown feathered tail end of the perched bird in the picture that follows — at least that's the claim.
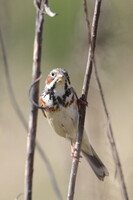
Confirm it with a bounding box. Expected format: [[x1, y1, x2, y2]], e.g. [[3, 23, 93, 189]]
[[82, 146, 109, 181]]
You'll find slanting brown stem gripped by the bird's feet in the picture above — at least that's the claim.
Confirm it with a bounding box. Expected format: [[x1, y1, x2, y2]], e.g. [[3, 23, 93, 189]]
[[67, 0, 101, 200]]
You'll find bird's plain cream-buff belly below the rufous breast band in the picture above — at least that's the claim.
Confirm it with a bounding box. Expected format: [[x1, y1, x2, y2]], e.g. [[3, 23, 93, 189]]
[[46, 105, 79, 141]]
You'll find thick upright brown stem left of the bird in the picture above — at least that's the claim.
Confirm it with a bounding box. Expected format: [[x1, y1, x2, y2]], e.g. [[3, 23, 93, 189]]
[[24, 4, 44, 200]]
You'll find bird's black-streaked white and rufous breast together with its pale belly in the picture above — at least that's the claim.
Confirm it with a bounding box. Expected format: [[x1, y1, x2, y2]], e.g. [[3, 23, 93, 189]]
[[41, 88, 79, 141]]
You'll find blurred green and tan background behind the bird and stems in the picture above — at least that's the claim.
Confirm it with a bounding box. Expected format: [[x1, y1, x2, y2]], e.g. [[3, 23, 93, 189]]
[[0, 0, 133, 200]]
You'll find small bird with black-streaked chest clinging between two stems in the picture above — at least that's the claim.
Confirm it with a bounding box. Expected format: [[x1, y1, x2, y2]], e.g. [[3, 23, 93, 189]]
[[39, 68, 109, 181]]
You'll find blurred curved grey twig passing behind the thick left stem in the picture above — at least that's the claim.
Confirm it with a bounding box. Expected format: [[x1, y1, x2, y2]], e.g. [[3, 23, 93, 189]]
[[0, 28, 63, 200]]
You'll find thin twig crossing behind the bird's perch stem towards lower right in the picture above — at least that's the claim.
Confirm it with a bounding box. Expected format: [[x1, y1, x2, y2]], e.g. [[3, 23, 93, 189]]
[[83, 0, 129, 200]]
